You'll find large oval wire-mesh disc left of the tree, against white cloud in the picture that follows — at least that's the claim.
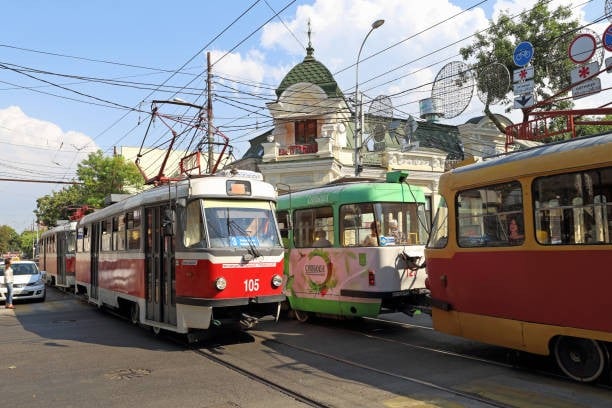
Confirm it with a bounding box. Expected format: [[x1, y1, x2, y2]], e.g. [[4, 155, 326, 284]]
[[431, 61, 474, 119]]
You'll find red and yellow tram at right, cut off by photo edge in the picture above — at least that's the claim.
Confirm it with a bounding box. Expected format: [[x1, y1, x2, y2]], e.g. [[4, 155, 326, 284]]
[[425, 134, 612, 382]]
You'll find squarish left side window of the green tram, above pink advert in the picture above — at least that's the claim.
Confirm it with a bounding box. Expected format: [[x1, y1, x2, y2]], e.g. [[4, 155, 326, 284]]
[[293, 207, 335, 248]]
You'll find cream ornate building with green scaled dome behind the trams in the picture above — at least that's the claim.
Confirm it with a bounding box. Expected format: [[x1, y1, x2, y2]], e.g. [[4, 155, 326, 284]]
[[231, 32, 505, 214]]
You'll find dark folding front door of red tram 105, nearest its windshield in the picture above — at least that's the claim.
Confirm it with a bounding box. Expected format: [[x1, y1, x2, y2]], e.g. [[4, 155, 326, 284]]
[[145, 206, 176, 325]]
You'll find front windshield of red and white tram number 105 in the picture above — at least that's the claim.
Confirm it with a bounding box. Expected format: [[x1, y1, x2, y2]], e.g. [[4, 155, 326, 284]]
[[183, 199, 280, 248]]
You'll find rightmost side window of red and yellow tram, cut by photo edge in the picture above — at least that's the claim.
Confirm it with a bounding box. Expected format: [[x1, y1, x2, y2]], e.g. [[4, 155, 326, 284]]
[[532, 167, 612, 245]]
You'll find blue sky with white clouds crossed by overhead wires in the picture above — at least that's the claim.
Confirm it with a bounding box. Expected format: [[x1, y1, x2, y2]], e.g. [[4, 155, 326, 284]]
[[0, 0, 612, 233]]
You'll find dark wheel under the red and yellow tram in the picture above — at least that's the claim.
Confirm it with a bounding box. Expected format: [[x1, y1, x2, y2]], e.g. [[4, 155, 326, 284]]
[[554, 336, 608, 382]]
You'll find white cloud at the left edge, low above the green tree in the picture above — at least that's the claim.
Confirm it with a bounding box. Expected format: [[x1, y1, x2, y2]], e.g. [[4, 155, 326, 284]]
[[0, 106, 97, 233]]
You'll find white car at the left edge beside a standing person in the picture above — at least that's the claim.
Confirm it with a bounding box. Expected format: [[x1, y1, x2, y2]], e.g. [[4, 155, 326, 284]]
[[0, 261, 47, 302]]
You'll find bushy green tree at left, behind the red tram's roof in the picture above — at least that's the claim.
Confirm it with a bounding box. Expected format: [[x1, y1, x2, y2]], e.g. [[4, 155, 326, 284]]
[[34, 150, 144, 226]]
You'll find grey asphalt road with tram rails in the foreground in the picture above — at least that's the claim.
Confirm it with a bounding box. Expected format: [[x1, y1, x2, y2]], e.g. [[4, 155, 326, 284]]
[[0, 289, 612, 408]]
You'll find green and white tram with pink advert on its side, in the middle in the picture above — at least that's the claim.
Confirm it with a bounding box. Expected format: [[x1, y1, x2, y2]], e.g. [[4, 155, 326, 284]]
[[277, 172, 429, 320]]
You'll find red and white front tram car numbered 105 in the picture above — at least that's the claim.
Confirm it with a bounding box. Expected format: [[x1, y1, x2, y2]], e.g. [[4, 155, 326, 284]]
[[75, 172, 285, 333]]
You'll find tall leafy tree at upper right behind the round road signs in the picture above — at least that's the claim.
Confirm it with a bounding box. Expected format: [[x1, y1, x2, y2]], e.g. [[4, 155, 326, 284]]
[[459, 0, 580, 132]]
